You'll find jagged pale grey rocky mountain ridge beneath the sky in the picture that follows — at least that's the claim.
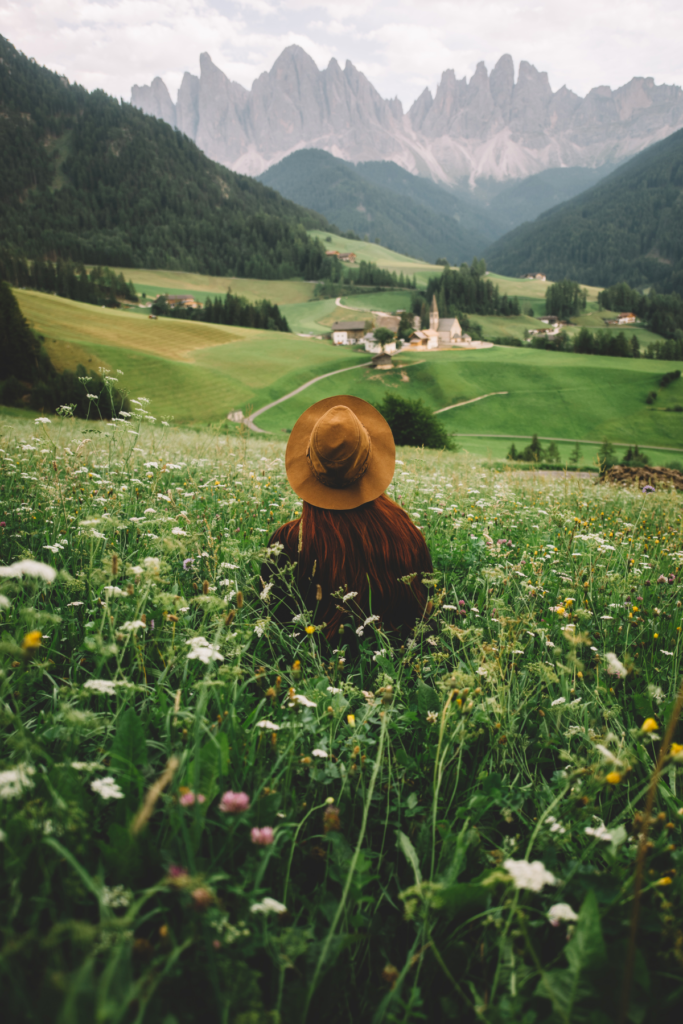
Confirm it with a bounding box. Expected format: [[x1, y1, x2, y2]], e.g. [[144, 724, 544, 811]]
[[131, 46, 683, 184]]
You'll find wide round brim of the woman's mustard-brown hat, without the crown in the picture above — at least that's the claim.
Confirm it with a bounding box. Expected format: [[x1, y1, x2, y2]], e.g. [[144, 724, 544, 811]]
[[285, 394, 396, 510]]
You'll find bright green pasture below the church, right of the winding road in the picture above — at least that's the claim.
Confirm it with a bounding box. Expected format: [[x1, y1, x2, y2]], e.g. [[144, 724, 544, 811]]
[[257, 346, 683, 458]]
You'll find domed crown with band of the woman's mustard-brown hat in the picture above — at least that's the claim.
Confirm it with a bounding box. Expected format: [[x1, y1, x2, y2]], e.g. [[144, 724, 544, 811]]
[[307, 406, 372, 487]]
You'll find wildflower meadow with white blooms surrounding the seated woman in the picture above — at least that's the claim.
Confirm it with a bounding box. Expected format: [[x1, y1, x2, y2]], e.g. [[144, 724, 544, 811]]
[[0, 398, 683, 1024]]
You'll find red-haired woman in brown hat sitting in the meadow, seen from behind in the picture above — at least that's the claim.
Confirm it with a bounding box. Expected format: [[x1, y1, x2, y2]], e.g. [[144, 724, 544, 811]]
[[262, 395, 432, 642]]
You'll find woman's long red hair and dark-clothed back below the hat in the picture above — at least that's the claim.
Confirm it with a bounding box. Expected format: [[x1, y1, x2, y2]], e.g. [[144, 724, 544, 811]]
[[272, 495, 432, 639]]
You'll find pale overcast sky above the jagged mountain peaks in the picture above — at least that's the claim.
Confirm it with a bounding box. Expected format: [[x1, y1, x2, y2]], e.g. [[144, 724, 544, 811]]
[[0, 0, 683, 106]]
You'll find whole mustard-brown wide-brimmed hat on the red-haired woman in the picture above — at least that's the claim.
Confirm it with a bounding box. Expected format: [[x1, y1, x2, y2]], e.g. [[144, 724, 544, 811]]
[[285, 394, 396, 509]]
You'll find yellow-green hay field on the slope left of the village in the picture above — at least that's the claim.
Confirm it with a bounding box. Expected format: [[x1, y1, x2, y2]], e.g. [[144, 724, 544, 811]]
[[14, 289, 367, 423]]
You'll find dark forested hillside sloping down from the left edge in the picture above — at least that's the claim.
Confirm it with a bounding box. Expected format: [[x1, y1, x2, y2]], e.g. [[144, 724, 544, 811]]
[[0, 36, 328, 278]]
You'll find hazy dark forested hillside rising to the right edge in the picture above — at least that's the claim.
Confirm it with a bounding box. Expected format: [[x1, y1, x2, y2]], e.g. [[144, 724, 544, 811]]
[[486, 131, 683, 292]]
